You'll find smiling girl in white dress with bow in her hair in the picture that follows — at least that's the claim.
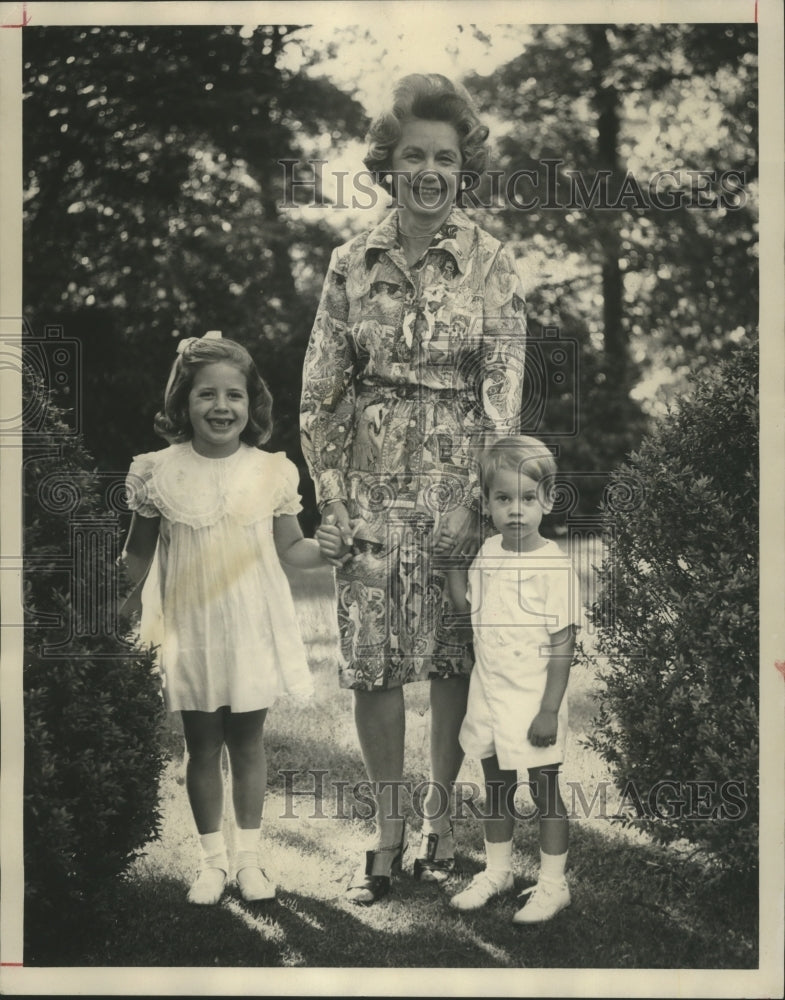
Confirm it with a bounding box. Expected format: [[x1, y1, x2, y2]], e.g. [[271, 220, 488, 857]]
[[122, 331, 330, 904]]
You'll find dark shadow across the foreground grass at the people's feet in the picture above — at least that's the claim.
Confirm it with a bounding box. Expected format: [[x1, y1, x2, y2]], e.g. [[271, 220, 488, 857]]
[[39, 824, 757, 969]]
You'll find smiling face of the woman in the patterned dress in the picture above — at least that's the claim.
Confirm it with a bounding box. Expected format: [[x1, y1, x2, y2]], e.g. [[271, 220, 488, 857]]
[[392, 118, 461, 217]]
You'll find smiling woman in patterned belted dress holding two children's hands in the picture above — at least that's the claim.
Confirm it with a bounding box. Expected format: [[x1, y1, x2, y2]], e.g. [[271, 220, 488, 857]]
[[301, 74, 525, 905]]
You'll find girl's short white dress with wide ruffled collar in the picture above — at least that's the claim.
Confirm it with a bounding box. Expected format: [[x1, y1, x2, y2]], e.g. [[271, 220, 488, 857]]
[[127, 442, 313, 712]]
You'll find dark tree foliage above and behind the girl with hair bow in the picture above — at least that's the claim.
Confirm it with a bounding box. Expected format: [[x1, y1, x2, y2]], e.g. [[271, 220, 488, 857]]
[[23, 25, 365, 524]]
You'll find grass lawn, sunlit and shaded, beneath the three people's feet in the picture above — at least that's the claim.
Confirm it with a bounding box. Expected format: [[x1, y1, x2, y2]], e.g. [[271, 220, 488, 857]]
[[29, 556, 757, 969]]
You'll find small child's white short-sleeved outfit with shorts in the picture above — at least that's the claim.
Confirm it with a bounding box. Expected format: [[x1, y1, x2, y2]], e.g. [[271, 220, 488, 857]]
[[460, 535, 582, 771]]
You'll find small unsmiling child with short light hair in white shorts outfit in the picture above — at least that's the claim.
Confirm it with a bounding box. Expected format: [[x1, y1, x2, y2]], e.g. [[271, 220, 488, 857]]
[[449, 437, 581, 924]]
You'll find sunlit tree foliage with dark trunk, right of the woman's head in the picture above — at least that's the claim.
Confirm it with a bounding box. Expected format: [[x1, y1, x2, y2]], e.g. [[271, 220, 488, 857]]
[[467, 25, 758, 509]]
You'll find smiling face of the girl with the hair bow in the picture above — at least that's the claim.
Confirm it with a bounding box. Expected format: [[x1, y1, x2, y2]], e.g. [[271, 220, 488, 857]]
[[188, 361, 248, 458]]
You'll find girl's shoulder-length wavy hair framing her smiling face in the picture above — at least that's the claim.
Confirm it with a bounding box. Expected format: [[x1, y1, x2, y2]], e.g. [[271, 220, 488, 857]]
[[154, 337, 273, 448]]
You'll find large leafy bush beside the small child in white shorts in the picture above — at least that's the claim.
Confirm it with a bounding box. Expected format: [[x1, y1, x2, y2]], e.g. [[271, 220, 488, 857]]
[[583, 343, 758, 877]]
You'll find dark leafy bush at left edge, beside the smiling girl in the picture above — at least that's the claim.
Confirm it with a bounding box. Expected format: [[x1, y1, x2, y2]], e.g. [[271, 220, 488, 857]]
[[23, 372, 164, 964]]
